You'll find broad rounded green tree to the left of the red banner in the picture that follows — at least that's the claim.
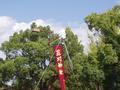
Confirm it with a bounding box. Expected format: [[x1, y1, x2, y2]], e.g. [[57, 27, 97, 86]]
[[0, 23, 56, 90]]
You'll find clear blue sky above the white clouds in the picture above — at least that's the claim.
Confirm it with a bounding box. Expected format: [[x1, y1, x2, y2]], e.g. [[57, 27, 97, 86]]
[[0, 0, 118, 24]]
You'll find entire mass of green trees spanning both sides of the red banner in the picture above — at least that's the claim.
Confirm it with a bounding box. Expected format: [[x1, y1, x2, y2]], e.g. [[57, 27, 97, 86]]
[[0, 6, 120, 90]]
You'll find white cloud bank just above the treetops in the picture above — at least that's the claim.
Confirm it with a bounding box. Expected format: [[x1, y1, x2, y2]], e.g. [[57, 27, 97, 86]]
[[0, 16, 88, 56]]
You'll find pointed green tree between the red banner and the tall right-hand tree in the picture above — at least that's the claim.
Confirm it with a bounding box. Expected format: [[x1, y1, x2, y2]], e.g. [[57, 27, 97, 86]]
[[65, 28, 104, 90]]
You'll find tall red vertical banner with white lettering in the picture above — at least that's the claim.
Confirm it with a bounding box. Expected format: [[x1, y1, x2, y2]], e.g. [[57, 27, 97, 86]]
[[53, 45, 65, 90]]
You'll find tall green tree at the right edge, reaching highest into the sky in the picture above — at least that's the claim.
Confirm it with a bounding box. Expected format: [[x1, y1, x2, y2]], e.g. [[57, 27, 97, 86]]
[[85, 6, 120, 90]]
